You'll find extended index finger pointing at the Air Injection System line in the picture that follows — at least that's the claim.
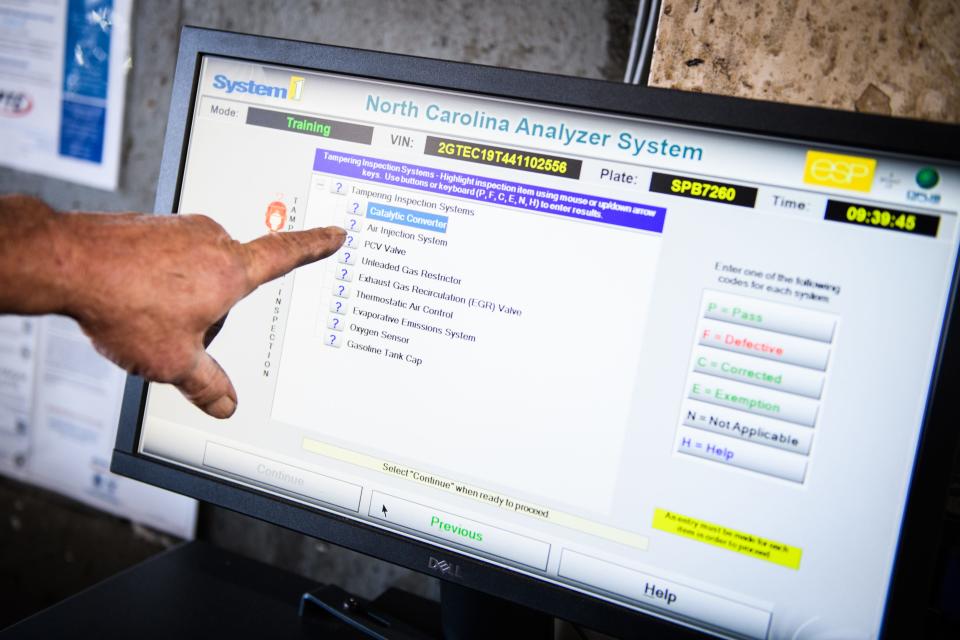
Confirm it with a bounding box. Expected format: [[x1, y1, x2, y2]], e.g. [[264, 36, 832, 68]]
[[242, 227, 347, 289]]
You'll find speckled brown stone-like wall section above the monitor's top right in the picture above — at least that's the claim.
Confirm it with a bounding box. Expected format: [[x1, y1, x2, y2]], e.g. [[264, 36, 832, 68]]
[[649, 0, 960, 123]]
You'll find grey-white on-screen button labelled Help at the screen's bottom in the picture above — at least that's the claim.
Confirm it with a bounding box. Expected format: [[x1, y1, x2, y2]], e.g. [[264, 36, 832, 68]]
[[559, 549, 770, 638]]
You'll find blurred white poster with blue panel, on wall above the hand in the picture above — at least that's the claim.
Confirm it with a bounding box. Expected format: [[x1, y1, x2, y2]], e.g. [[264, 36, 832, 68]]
[[0, 0, 133, 190]]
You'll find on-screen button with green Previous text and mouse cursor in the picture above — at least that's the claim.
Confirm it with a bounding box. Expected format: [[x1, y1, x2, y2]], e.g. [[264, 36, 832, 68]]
[[368, 491, 550, 571]]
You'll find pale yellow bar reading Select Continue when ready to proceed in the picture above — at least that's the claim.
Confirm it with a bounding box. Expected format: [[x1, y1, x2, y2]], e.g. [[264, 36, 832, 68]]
[[302, 438, 649, 550]]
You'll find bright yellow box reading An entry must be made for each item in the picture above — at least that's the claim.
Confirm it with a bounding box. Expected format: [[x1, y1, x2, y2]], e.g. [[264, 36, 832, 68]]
[[653, 509, 803, 569]]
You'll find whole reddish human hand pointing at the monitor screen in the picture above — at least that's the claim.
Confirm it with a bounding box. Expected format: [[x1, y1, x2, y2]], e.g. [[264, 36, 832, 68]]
[[53, 213, 346, 418]]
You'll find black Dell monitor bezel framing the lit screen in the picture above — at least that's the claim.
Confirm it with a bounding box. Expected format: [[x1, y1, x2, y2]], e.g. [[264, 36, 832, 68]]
[[111, 27, 960, 637]]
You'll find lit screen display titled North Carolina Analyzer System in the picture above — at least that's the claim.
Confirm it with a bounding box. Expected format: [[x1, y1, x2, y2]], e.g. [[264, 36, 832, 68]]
[[140, 57, 960, 638]]
